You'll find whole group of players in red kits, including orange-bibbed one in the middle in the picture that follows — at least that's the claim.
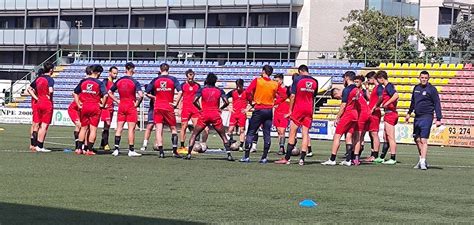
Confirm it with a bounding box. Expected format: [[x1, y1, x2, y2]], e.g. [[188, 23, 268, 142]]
[[28, 62, 440, 166]]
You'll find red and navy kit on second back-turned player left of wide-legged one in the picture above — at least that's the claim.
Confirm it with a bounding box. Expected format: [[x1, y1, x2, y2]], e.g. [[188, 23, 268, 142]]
[[110, 76, 142, 123]]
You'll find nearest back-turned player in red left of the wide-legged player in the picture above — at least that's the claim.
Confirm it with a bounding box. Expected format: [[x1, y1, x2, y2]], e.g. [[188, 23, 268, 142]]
[[146, 63, 182, 158]]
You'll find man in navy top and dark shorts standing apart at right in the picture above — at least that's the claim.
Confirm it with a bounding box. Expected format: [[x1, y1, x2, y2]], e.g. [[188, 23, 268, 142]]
[[405, 71, 443, 170]]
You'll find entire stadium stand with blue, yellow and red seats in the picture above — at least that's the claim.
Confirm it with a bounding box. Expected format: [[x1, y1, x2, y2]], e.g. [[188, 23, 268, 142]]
[[7, 60, 474, 125]]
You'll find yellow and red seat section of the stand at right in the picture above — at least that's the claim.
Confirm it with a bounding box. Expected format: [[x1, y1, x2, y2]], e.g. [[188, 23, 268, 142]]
[[315, 63, 474, 125]]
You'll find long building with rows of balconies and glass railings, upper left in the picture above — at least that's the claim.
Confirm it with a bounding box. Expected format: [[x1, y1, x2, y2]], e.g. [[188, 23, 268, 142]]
[[0, 0, 303, 72]]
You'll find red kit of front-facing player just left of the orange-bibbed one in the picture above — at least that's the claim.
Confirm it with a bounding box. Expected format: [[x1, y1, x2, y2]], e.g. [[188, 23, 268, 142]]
[[226, 89, 248, 127]]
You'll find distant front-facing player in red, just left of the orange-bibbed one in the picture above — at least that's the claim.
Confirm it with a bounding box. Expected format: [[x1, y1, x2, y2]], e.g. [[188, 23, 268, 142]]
[[227, 79, 248, 151]]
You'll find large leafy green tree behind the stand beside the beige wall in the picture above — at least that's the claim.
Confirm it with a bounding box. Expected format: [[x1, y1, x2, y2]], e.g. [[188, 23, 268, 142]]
[[340, 10, 450, 66]]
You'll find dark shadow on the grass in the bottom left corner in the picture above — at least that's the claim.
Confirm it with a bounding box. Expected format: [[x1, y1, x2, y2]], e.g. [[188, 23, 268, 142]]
[[0, 202, 202, 225]]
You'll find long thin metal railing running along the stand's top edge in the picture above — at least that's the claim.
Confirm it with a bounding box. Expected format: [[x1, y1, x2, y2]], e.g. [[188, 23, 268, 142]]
[[63, 48, 474, 67]]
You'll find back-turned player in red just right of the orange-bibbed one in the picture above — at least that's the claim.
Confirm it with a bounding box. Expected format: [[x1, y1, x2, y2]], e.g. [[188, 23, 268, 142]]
[[275, 65, 318, 166]]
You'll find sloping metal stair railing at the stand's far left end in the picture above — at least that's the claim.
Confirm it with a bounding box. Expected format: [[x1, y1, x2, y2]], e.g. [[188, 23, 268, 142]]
[[5, 49, 63, 103]]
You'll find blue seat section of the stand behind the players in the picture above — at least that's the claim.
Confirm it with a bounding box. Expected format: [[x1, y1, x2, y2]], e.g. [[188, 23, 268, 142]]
[[8, 60, 365, 109]]
